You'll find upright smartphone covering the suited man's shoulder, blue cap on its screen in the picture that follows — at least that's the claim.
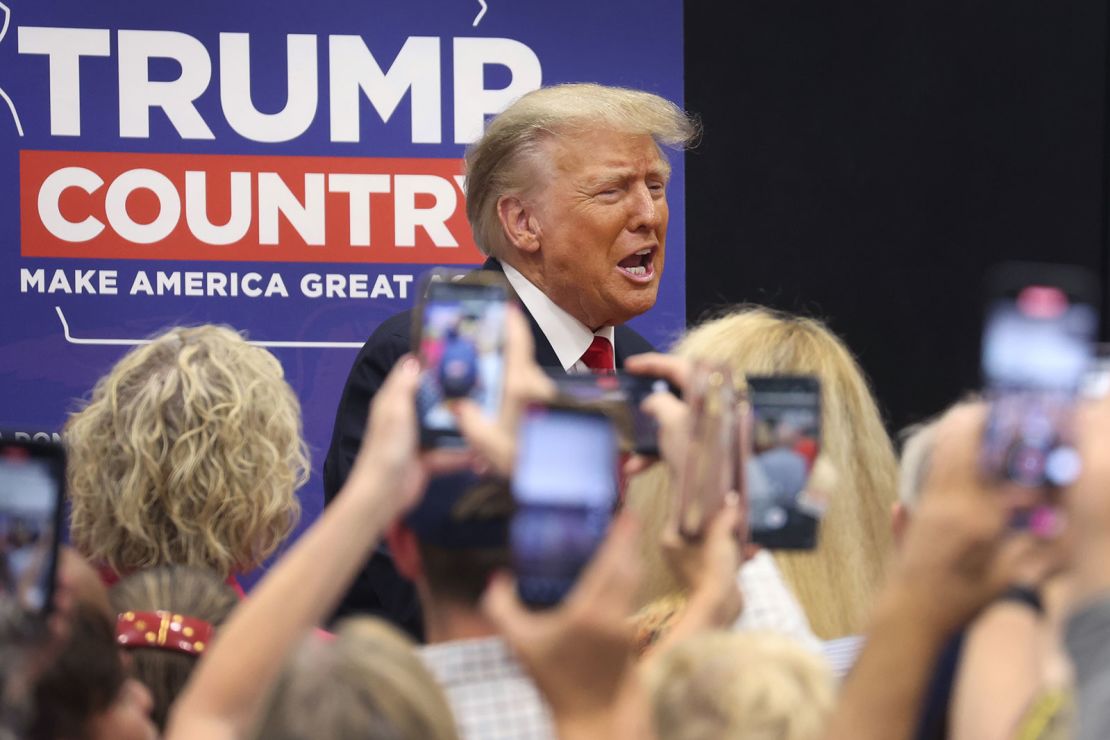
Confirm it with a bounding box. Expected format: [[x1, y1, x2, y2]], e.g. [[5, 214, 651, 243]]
[[413, 270, 511, 448]]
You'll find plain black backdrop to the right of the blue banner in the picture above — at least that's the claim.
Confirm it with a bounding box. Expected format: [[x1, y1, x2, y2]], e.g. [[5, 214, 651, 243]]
[[686, 0, 1110, 429]]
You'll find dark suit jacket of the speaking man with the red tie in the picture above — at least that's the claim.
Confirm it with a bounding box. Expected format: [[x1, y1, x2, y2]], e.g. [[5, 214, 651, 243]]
[[324, 257, 653, 638]]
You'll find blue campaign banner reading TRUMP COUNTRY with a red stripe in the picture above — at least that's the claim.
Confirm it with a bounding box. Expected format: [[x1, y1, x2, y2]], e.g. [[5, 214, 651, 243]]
[[0, 0, 685, 568]]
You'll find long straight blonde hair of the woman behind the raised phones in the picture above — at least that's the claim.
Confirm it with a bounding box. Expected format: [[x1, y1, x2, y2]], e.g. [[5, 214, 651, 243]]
[[629, 306, 898, 639]]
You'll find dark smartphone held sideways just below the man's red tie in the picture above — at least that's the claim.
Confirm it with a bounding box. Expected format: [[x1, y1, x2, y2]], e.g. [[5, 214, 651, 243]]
[[549, 371, 673, 457]]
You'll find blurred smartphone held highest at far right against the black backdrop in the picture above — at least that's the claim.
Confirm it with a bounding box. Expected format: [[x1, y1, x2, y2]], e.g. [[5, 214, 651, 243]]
[[981, 264, 1099, 529]]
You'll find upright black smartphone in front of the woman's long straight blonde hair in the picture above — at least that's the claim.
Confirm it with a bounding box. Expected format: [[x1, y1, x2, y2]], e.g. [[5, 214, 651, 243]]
[[744, 375, 824, 550]]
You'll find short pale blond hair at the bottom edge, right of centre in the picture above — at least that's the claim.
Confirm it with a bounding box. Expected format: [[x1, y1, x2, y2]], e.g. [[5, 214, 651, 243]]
[[647, 632, 834, 740]]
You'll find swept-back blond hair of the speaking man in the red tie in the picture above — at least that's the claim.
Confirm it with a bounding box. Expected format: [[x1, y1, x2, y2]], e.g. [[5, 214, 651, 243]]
[[466, 83, 699, 256]]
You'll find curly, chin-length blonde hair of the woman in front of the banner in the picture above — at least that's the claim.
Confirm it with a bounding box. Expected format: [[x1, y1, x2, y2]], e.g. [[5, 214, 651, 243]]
[[64, 326, 309, 577]]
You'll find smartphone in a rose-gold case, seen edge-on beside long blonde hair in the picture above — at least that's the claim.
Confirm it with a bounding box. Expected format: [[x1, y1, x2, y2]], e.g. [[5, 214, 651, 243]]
[[677, 364, 738, 539]]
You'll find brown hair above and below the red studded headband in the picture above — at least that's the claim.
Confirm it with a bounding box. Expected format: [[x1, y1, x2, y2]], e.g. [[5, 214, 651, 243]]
[[109, 566, 239, 729]]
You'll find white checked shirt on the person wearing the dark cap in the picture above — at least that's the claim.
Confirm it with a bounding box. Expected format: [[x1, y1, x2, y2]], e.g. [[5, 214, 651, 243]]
[[420, 637, 555, 740]]
